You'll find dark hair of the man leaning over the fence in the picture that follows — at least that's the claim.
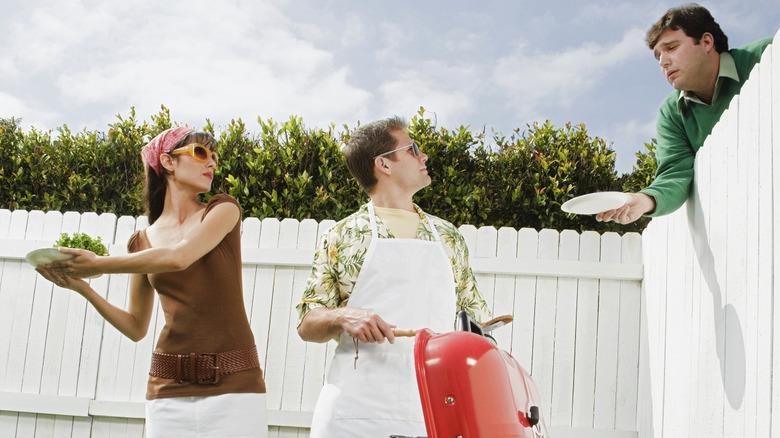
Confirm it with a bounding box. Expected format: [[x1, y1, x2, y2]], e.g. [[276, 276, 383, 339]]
[[645, 3, 729, 53]]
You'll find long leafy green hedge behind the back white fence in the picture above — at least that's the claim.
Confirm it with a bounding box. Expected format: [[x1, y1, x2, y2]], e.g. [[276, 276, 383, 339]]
[[0, 107, 655, 231]]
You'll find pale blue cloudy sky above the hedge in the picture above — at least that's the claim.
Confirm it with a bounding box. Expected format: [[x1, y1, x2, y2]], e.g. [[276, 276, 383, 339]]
[[0, 0, 780, 173]]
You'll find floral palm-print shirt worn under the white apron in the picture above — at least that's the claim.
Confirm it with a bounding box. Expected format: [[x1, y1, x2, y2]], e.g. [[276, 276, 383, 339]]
[[296, 204, 490, 324]]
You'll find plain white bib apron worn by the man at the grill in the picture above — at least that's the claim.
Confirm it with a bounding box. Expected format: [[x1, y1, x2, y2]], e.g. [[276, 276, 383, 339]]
[[310, 203, 456, 438]]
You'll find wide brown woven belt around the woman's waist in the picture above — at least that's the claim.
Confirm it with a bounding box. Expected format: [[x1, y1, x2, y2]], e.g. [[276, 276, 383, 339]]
[[149, 345, 260, 385]]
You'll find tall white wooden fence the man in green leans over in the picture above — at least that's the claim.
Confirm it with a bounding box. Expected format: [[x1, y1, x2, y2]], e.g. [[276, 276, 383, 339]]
[[639, 32, 780, 438]]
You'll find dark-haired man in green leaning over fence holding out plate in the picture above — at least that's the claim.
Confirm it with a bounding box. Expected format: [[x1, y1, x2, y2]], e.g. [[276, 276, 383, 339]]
[[596, 4, 772, 224]]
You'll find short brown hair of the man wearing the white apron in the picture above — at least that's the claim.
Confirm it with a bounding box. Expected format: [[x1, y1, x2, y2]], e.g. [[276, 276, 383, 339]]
[[344, 116, 406, 193]]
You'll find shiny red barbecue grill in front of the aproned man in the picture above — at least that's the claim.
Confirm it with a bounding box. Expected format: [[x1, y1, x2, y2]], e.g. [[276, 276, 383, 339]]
[[395, 312, 549, 438]]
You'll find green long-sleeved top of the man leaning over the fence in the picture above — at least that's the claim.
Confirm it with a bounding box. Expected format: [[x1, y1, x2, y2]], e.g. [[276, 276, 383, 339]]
[[641, 38, 772, 216]]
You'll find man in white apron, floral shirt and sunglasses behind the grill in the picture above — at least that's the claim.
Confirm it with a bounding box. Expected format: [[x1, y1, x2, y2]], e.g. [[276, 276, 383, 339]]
[[297, 114, 489, 438]]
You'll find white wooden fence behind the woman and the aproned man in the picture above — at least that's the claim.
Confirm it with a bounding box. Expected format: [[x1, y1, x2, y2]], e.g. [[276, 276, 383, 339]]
[[0, 210, 642, 438]]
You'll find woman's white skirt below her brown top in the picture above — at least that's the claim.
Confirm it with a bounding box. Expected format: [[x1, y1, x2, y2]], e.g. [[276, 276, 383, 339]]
[[145, 393, 268, 438]]
